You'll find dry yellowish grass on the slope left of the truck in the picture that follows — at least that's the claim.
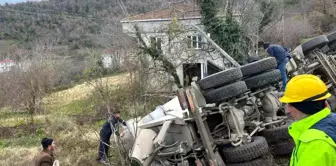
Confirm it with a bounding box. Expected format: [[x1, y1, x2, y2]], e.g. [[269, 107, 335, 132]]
[[0, 74, 133, 166]]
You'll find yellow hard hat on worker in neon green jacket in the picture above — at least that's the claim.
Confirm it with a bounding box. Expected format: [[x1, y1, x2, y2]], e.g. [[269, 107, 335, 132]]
[[280, 74, 331, 103]]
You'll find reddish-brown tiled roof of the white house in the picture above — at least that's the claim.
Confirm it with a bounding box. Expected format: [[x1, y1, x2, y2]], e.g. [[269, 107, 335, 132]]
[[122, 3, 201, 22]]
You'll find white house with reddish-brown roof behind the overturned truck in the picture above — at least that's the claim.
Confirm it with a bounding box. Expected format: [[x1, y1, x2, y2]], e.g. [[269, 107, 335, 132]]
[[121, 3, 242, 86]]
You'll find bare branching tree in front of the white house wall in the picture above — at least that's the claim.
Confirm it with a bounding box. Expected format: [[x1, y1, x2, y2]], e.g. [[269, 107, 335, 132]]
[[134, 19, 204, 89]]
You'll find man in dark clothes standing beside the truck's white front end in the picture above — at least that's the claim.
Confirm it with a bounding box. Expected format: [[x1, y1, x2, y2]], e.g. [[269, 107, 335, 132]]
[[97, 111, 126, 163]]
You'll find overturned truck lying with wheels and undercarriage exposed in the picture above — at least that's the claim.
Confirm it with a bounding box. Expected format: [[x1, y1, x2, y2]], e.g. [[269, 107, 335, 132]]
[[121, 30, 336, 166]]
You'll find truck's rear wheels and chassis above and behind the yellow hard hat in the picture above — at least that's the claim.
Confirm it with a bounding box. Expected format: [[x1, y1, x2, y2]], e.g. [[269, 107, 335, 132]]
[[287, 32, 336, 109]]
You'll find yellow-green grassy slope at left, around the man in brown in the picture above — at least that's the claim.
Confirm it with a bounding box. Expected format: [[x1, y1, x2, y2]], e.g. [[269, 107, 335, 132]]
[[0, 74, 128, 166]]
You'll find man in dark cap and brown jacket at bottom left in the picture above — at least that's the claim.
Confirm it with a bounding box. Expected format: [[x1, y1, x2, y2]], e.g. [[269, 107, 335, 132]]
[[35, 138, 55, 166]]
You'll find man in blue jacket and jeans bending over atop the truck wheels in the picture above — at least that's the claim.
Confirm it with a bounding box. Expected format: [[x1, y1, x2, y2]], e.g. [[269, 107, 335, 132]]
[[260, 42, 291, 91]]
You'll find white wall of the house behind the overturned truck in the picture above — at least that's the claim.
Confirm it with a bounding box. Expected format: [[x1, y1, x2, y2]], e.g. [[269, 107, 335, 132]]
[[122, 17, 234, 89]]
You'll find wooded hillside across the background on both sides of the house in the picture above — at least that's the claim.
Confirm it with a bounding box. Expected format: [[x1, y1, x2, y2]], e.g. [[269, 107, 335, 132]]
[[0, 0, 336, 53]]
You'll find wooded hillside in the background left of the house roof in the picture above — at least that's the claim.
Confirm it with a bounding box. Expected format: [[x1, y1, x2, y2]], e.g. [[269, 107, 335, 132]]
[[0, 0, 169, 49]]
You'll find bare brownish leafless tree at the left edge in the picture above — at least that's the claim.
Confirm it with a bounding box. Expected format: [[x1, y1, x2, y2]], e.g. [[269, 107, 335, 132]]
[[0, 41, 59, 127]]
